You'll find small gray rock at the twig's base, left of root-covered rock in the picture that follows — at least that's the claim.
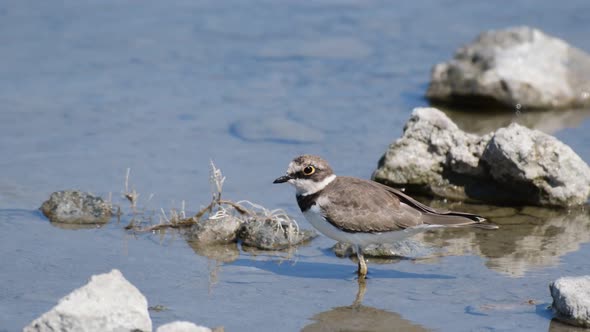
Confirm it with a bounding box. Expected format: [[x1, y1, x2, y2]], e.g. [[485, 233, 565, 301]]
[[185, 215, 242, 245]]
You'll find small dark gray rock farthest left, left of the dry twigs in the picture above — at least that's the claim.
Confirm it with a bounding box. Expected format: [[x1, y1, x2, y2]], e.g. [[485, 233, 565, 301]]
[[40, 190, 112, 224]]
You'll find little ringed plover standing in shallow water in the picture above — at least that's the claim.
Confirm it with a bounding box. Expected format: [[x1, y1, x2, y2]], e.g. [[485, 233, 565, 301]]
[[273, 155, 497, 279]]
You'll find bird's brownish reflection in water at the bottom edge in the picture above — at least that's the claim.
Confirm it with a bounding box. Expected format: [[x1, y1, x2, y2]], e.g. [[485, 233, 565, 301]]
[[302, 280, 428, 332]]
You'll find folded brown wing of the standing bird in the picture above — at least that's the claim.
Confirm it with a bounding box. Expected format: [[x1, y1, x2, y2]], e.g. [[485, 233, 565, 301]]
[[318, 177, 496, 232]]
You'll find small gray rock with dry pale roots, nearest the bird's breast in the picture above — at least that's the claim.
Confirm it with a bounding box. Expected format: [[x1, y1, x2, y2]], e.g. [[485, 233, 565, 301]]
[[238, 218, 317, 250]]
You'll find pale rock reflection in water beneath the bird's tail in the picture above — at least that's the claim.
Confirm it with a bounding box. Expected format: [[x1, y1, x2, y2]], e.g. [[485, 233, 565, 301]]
[[414, 201, 590, 277]]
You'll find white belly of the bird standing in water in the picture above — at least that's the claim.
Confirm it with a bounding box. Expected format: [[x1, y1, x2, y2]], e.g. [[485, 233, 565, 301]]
[[303, 204, 430, 247]]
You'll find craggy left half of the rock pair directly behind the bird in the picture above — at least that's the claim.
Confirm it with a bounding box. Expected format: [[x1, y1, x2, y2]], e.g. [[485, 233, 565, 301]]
[[373, 108, 498, 200]]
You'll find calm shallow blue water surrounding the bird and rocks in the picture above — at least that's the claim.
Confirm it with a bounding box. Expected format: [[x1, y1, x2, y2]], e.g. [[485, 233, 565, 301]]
[[0, 0, 590, 331]]
